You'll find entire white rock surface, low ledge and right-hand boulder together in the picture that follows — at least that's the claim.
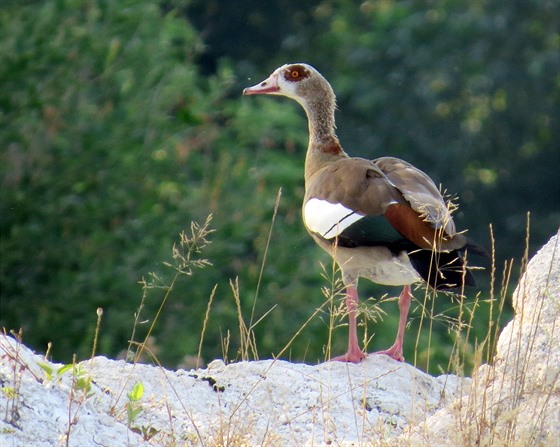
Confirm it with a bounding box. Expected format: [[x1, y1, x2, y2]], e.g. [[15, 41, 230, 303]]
[[0, 236, 560, 447]]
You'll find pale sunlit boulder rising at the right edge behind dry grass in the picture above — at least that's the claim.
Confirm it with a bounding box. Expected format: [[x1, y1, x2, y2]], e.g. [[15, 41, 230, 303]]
[[399, 234, 560, 447]]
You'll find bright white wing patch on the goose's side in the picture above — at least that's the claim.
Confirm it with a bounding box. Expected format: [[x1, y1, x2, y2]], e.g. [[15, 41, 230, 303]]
[[303, 199, 364, 239]]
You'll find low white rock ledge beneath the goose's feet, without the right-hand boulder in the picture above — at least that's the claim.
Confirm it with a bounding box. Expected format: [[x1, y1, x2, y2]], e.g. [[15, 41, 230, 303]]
[[0, 336, 469, 447]]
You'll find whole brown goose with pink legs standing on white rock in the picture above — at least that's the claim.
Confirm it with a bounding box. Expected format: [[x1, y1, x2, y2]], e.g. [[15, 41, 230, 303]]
[[243, 63, 483, 363]]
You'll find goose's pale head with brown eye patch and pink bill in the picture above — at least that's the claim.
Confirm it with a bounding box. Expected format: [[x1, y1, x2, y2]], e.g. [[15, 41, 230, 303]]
[[243, 63, 335, 110]]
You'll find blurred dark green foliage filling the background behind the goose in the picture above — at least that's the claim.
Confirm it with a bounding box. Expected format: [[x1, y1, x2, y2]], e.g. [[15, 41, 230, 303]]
[[0, 0, 560, 368]]
